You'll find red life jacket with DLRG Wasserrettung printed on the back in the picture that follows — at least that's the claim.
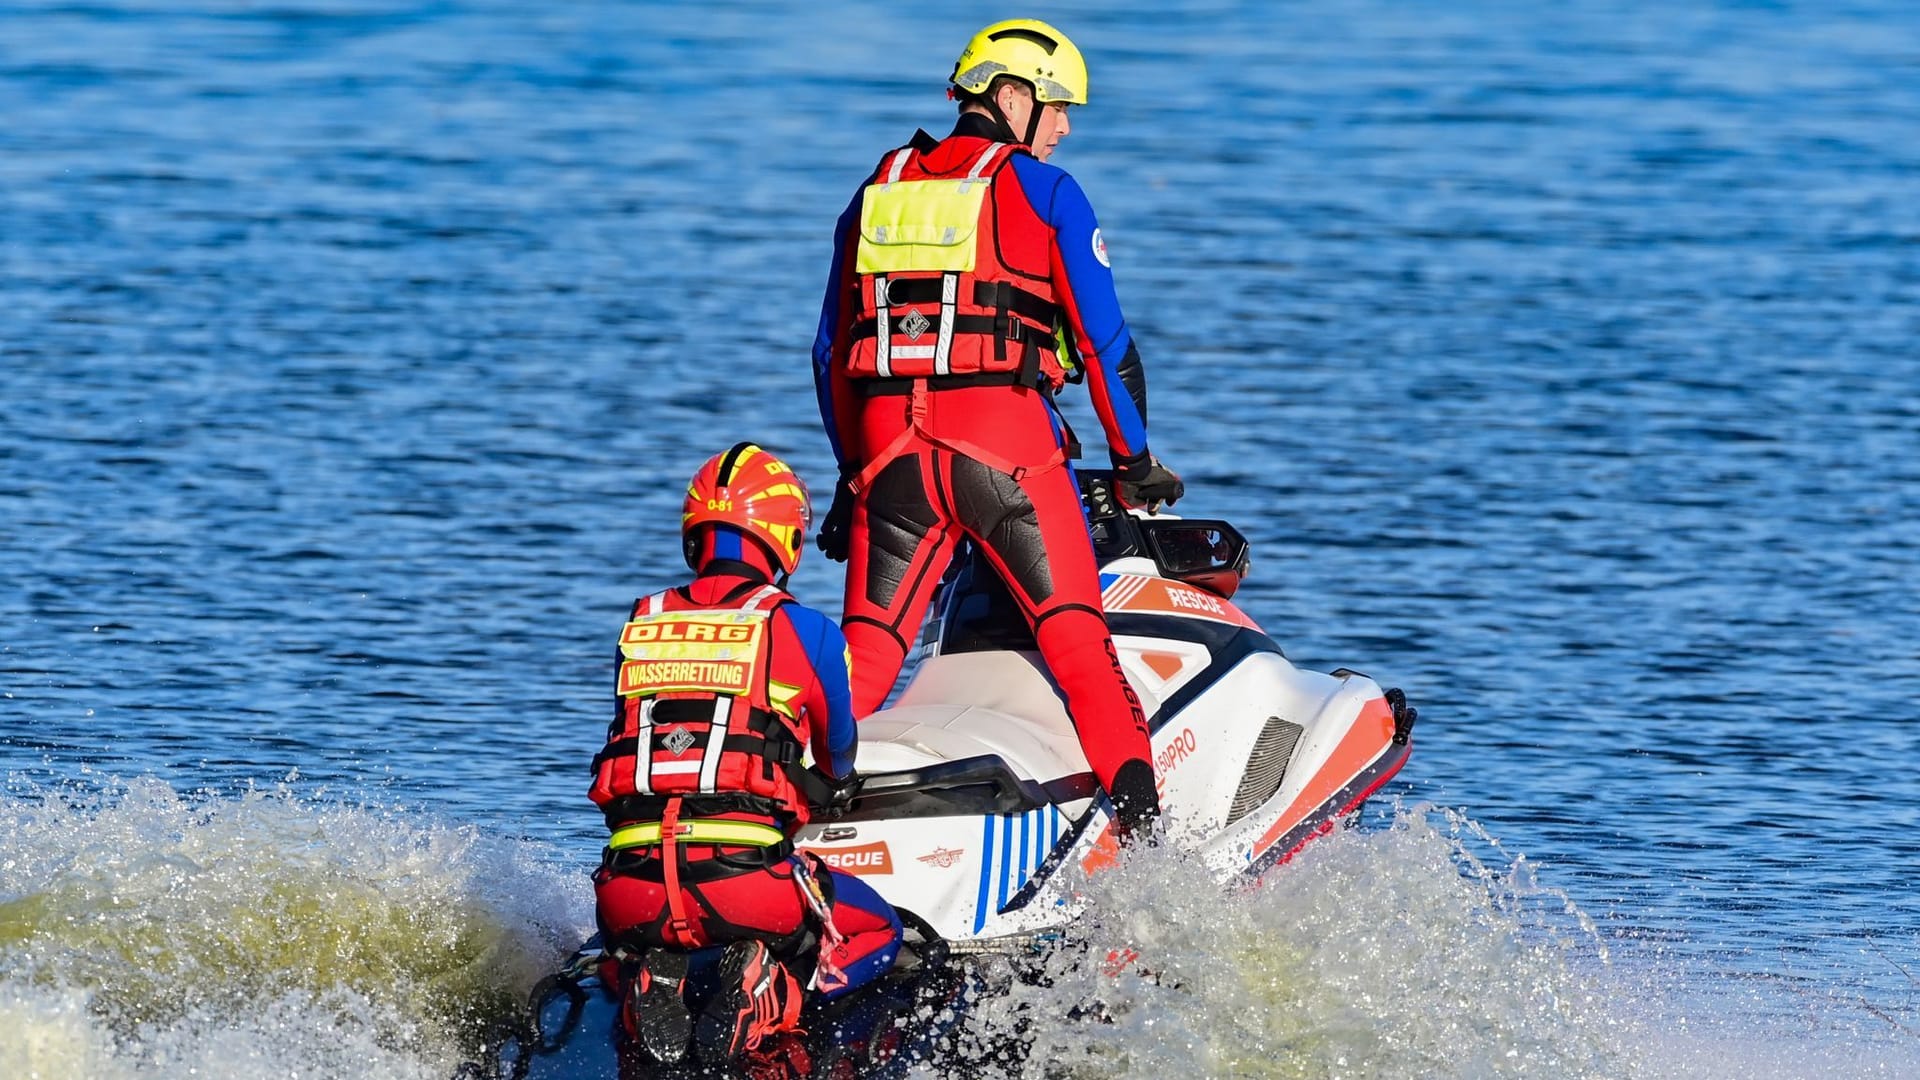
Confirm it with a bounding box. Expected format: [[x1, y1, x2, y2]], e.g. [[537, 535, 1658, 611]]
[[588, 584, 808, 826]]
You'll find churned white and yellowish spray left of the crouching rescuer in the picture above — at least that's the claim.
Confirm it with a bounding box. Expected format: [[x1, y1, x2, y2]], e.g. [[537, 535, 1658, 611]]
[[0, 780, 584, 1078]]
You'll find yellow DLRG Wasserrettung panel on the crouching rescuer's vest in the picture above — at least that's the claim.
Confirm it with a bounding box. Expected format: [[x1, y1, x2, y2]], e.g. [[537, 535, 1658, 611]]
[[620, 611, 768, 696]]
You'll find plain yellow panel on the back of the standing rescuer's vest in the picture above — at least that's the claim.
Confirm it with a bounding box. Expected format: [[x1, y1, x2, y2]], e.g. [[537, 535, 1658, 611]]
[[854, 179, 993, 273]]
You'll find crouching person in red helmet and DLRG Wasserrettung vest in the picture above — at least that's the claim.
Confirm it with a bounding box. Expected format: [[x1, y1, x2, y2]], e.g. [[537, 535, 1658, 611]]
[[589, 442, 900, 1063]]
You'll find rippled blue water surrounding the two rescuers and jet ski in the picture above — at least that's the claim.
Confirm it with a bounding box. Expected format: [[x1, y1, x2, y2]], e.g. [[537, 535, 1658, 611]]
[[0, 0, 1920, 1076]]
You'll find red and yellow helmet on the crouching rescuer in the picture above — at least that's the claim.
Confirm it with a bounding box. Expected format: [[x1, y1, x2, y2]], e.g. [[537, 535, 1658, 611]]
[[680, 442, 814, 575]]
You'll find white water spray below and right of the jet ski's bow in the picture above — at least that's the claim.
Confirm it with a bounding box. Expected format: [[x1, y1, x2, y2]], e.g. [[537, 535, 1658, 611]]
[[936, 805, 1920, 1080]]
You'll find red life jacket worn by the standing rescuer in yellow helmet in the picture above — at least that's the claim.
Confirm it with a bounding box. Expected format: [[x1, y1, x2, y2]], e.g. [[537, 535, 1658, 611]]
[[845, 135, 1066, 390]]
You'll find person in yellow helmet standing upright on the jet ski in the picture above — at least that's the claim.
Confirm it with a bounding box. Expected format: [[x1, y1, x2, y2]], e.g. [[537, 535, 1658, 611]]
[[814, 19, 1183, 828]]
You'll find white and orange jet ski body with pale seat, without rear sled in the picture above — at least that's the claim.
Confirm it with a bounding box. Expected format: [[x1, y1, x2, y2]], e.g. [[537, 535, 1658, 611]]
[[801, 522, 1413, 945]]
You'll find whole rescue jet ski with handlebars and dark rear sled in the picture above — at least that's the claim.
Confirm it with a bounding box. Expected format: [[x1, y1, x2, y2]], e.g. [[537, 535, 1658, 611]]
[[476, 471, 1417, 1078]]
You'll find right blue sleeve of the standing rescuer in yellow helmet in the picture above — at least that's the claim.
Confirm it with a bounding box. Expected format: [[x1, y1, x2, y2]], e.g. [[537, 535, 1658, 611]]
[[1012, 154, 1146, 457]]
